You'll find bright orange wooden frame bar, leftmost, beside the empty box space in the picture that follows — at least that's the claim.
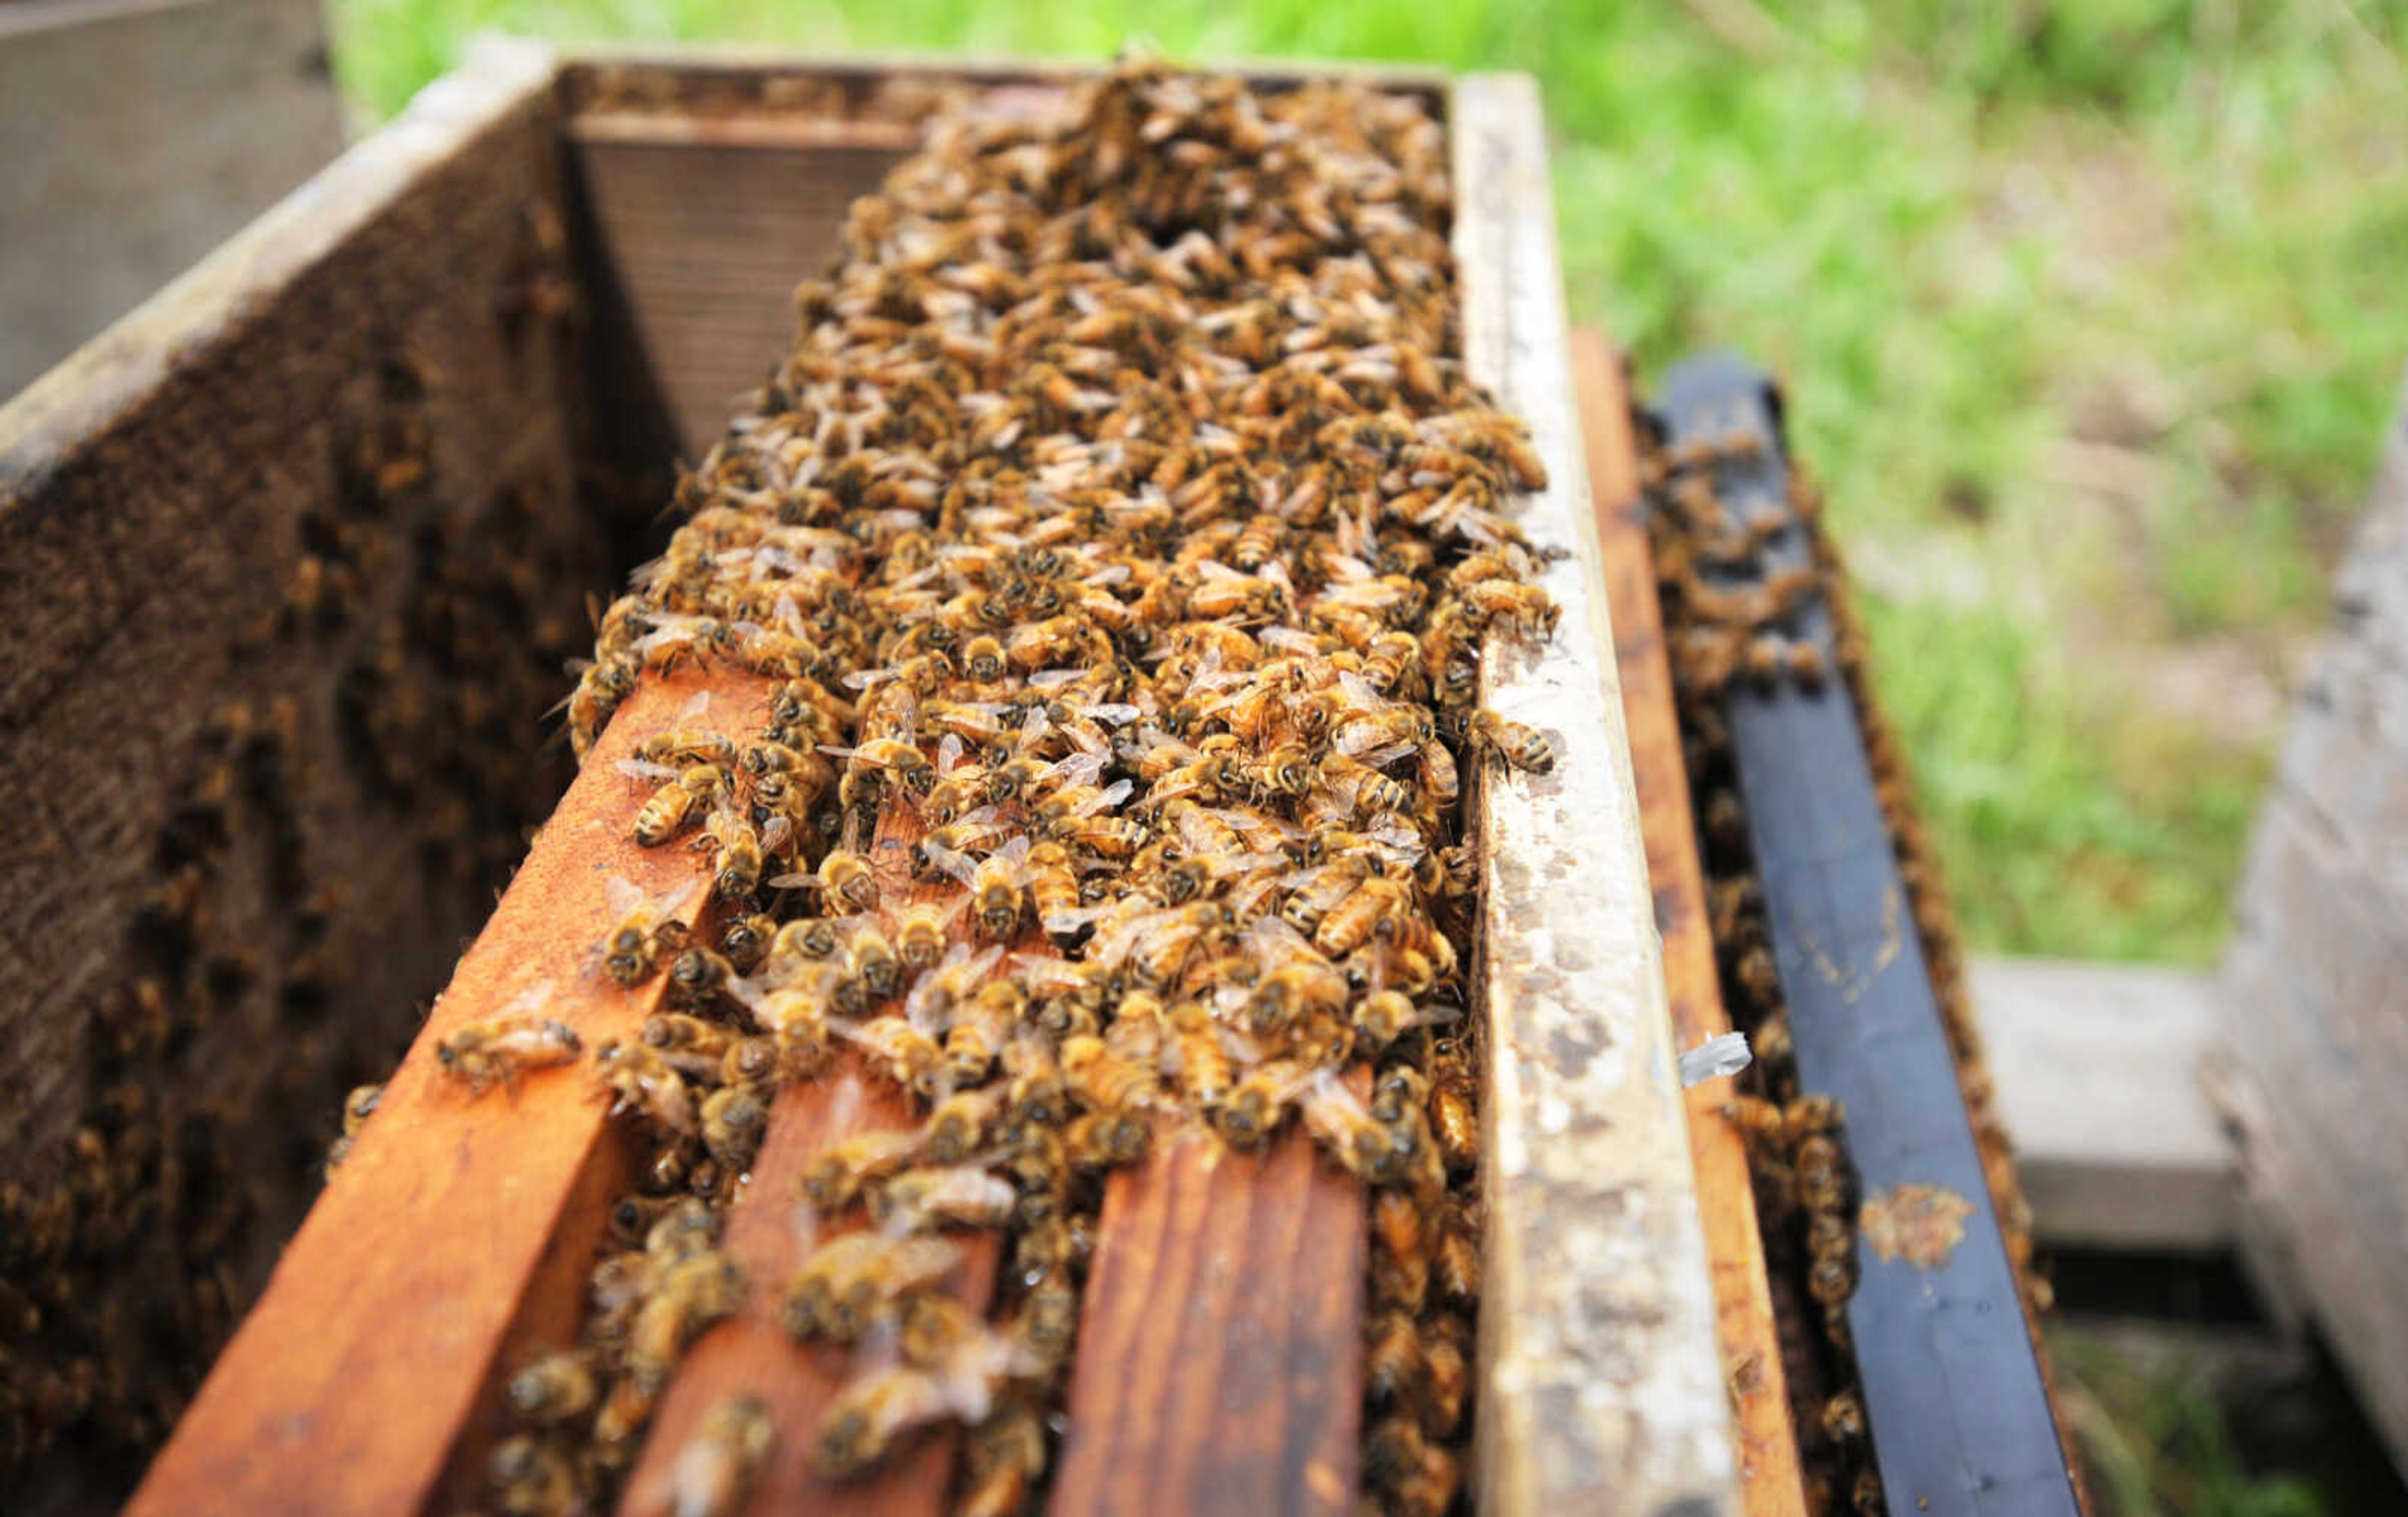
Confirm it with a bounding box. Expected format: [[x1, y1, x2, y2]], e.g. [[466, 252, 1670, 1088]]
[[128, 674, 768, 1517]]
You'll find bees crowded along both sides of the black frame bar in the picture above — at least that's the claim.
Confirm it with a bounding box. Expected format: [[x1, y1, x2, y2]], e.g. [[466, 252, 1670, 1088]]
[[1645, 421, 2047, 1512]]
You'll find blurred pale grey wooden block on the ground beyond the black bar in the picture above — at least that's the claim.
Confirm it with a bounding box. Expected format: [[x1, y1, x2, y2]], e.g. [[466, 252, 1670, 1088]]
[[1970, 958, 2239, 1252]]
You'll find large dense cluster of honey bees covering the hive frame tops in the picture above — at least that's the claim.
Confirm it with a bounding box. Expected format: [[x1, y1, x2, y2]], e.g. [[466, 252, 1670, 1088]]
[[483, 63, 1556, 1512]]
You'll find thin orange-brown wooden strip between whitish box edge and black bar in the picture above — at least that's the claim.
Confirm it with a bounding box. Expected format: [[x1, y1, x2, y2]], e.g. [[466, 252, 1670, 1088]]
[[1573, 330, 1806, 1517]]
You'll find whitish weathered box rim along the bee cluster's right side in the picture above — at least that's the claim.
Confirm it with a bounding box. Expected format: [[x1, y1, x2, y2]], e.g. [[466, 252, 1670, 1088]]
[[1447, 75, 1738, 1512]]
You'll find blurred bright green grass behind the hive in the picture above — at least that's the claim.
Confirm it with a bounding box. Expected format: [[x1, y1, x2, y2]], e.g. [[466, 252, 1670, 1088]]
[[330, 0, 2408, 961]]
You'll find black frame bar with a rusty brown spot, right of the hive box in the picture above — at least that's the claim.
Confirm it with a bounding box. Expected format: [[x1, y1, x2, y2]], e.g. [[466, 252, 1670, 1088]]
[[1657, 354, 2081, 1517]]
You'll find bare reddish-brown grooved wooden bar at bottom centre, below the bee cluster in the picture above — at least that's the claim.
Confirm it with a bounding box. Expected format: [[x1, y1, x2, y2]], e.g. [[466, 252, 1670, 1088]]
[[1050, 1129, 1368, 1517]]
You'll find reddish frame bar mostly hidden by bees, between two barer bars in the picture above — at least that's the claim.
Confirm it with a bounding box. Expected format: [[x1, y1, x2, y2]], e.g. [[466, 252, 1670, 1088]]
[[621, 804, 1001, 1517]]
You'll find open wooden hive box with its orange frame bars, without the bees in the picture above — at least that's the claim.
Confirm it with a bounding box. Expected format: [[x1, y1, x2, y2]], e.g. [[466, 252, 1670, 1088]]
[[0, 41, 2071, 1512]]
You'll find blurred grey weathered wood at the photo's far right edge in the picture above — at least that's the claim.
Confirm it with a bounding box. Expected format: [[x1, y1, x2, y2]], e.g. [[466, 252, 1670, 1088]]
[[2215, 375, 2408, 1464]]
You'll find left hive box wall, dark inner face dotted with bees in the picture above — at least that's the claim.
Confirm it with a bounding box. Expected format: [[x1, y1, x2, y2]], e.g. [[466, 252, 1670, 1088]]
[[0, 35, 614, 1509]]
